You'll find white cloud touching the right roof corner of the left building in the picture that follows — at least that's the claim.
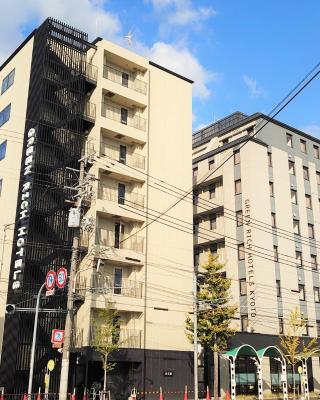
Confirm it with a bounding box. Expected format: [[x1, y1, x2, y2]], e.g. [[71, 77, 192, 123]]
[[149, 42, 217, 99]]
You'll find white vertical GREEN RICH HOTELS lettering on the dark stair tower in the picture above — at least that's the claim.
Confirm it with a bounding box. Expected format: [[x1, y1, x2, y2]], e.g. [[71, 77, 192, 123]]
[[12, 128, 36, 291]]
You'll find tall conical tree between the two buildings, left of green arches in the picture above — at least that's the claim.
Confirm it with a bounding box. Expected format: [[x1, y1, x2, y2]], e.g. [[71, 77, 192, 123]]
[[186, 254, 237, 400]]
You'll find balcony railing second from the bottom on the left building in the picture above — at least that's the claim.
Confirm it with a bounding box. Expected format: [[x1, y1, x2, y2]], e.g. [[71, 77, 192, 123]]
[[91, 274, 143, 299]]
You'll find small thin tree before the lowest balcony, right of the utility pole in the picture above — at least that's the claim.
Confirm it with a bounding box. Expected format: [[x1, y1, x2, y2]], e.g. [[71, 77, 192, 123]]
[[91, 306, 120, 394]]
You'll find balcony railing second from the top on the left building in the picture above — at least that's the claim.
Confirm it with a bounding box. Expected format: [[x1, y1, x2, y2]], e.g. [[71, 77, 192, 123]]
[[101, 102, 147, 131]]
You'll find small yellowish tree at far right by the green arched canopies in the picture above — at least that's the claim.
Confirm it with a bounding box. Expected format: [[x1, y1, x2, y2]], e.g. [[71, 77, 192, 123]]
[[280, 307, 319, 398]]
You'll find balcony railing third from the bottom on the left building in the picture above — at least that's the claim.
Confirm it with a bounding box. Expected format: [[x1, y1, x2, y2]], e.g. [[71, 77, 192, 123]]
[[97, 228, 144, 253]]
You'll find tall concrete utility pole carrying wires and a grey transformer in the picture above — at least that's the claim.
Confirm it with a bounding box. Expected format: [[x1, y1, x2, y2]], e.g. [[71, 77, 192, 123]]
[[59, 158, 84, 400]]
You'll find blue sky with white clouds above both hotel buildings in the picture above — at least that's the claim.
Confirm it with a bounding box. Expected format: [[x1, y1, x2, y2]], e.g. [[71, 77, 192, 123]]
[[0, 0, 320, 137]]
